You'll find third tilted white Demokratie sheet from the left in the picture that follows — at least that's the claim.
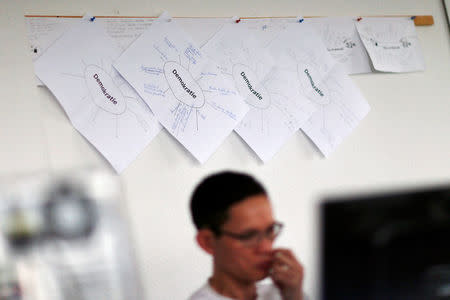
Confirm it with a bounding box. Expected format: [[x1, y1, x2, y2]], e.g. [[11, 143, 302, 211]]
[[202, 24, 315, 162]]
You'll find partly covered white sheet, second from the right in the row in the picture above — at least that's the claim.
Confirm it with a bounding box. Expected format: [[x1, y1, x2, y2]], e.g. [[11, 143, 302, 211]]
[[304, 17, 372, 74]]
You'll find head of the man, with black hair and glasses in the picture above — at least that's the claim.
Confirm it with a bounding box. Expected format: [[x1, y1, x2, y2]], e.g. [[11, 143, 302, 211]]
[[191, 172, 281, 282]]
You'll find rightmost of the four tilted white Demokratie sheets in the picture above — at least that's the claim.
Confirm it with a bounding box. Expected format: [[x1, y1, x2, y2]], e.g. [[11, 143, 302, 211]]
[[287, 39, 365, 156]]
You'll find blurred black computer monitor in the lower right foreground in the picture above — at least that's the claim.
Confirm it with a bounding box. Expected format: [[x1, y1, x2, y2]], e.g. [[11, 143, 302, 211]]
[[320, 185, 450, 300]]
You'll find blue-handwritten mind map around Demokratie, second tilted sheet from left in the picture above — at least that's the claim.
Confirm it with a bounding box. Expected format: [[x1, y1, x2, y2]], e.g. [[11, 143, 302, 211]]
[[141, 37, 244, 136]]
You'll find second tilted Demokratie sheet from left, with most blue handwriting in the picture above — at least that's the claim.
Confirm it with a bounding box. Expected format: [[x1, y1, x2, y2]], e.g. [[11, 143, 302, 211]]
[[114, 20, 248, 163]]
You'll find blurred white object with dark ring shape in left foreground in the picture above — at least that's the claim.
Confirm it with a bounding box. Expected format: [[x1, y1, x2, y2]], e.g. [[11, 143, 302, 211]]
[[0, 170, 142, 300]]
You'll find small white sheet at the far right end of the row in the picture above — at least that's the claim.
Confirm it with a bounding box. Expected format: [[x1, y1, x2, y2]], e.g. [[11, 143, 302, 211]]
[[356, 18, 425, 72]]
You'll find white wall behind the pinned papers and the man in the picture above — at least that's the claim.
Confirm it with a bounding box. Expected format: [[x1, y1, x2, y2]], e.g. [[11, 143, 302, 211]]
[[0, 0, 450, 300]]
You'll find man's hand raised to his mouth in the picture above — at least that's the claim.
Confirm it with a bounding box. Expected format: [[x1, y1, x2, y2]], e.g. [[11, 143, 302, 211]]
[[270, 249, 304, 300]]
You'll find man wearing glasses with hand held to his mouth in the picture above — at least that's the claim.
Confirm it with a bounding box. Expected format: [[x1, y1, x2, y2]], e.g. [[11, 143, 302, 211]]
[[189, 172, 306, 300]]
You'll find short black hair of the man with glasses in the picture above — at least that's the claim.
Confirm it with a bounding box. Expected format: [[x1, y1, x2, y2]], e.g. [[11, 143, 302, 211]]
[[190, 171, 267, 236]]
